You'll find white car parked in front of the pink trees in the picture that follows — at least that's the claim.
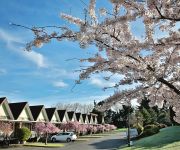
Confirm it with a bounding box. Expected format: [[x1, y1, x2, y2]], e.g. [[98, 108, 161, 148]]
[[51, 132, 77, 142]]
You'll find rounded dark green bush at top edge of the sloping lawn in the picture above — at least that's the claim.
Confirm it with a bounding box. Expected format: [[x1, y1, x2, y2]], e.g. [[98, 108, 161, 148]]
[[142, 125, 159, 137]]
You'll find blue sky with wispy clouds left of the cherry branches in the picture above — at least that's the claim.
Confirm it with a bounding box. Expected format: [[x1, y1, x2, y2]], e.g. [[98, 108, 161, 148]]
[[0, 0, 126, 106]]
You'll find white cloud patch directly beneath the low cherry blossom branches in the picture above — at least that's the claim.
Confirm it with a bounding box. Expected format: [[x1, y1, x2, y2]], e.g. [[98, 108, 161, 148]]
[[90, 77, 116, 88]]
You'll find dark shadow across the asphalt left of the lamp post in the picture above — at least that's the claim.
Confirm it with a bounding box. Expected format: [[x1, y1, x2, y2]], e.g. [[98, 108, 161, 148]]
[[90, 139, 127, 150]]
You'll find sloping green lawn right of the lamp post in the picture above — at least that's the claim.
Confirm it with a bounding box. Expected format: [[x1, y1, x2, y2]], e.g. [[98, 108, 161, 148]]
[[121, 126, 180, 150]]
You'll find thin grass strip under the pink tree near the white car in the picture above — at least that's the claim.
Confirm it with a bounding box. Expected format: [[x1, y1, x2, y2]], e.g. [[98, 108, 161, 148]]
[[24, 142, 64, 148]]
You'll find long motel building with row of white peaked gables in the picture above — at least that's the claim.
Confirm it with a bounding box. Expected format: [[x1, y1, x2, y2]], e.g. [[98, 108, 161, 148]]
[[0, 97, 104, 136]]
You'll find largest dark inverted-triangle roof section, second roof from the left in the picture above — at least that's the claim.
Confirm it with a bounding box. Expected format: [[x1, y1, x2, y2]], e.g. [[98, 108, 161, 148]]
[[9, 102, 27, 120]]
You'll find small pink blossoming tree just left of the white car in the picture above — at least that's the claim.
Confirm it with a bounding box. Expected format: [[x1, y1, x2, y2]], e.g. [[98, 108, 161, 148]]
[[35, 122, 60, 144]]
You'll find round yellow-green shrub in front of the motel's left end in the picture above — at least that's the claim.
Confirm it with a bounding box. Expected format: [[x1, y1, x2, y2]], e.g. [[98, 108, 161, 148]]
[[16, 127, 31, 141]]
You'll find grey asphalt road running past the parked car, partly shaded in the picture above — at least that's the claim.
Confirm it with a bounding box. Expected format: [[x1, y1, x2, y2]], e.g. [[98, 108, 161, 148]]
[[3, 133, 126, 150]]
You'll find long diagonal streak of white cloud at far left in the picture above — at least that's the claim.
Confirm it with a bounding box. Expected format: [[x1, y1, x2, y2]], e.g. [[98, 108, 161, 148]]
[[0, 28, 47, 67]]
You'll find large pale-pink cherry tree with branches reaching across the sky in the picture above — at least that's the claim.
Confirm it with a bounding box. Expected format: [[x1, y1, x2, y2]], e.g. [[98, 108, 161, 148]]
[[13, 0, 180, 121]]
